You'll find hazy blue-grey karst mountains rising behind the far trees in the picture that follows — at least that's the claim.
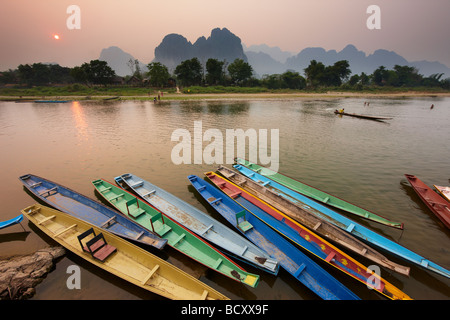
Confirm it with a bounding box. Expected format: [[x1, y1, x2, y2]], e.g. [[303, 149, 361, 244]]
[[99, 28, 450, 78]]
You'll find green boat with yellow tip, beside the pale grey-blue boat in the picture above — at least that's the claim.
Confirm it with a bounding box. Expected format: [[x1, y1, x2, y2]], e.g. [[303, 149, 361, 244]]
[[92, 179, 259, 287]]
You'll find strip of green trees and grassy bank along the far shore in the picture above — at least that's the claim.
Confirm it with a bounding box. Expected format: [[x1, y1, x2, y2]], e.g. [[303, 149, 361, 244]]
[[0, 58, 450, 100]]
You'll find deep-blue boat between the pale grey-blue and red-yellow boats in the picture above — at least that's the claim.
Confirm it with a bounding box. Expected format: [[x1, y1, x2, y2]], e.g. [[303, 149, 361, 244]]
[[188, 175, 359, 300]]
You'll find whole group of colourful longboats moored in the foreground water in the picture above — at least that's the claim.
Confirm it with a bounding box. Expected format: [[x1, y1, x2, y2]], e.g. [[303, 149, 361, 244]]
[[4, 158, 450, 300]]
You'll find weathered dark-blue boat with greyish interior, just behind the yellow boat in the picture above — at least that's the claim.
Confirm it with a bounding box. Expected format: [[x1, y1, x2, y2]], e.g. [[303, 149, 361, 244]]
[[19, 174, 167, 249]]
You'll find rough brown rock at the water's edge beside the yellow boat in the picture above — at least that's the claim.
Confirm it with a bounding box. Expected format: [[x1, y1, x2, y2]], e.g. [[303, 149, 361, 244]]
[[0, 247, 65, 300]]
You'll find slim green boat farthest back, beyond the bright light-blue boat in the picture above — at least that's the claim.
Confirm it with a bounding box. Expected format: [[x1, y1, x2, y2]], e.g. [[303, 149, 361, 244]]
[[235, 158, 403, 229]]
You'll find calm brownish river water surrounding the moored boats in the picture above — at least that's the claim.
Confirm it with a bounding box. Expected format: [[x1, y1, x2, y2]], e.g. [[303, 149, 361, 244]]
[[0, 97, 450, 300]]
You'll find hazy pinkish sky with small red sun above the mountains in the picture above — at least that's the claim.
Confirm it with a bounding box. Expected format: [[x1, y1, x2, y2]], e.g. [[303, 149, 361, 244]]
[[0, 0, 450, 71]]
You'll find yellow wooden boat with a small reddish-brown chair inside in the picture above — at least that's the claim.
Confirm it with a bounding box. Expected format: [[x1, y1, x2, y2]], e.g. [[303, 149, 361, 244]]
[[22, 204, 229, 300]]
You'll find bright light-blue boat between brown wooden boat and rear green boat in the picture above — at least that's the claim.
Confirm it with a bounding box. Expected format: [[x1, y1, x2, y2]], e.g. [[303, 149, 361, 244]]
[[233, 165, 450, 278]]
